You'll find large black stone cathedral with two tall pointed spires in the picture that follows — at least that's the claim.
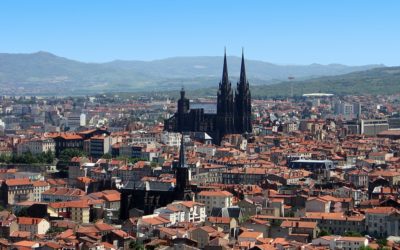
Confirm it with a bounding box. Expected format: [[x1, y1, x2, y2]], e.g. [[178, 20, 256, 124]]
[[164, 50, 252, 144]]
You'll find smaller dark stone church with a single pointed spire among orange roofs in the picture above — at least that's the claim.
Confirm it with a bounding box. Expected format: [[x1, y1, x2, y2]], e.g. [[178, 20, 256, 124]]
[[120, 136, 193, 221]]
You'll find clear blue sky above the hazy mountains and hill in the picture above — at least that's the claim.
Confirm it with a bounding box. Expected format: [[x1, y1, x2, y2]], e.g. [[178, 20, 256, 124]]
[[0, 0, 400, 65]]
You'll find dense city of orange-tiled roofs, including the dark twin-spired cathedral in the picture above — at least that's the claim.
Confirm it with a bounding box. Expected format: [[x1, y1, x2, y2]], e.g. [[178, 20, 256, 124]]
[[0, 48, 400, 250]]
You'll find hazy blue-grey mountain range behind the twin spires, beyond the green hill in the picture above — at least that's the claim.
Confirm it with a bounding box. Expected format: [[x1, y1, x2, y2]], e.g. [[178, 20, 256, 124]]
[[0, 52, 384, 95]]
